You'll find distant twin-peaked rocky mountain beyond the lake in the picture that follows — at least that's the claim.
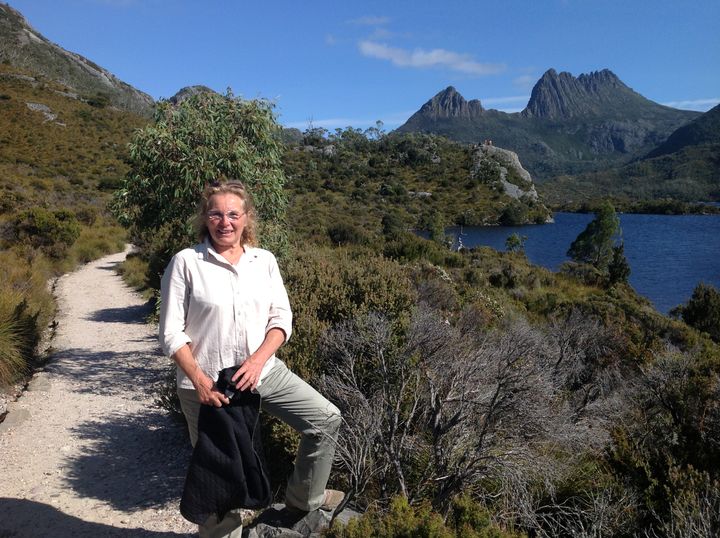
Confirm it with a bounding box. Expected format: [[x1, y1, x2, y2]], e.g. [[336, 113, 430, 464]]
[[398, 69, 699, 181]]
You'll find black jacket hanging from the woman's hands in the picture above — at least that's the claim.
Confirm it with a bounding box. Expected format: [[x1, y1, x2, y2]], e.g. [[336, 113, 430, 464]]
[[180, 366, 272, 525]]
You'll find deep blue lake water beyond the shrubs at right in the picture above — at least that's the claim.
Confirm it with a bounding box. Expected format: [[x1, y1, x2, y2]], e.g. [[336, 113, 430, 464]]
[[450, 213, 720, 313]]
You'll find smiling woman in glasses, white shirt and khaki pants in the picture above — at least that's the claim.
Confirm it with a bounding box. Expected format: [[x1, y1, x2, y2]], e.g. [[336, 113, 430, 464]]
[[160, 181, 343, 536]]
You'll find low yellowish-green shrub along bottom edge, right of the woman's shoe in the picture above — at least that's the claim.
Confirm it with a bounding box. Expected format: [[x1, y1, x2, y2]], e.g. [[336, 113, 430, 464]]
[[326, 497, 525, 538]]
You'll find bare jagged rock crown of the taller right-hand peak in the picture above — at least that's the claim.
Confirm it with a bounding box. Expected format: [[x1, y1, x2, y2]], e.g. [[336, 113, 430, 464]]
[[523, 69, 644, 119]]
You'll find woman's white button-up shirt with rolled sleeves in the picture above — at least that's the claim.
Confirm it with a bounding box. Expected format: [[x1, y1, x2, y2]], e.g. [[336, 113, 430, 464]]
[[159, 241, 292, 389]]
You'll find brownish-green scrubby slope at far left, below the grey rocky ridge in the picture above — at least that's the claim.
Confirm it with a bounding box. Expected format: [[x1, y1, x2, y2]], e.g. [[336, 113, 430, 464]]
[[0, 64, 148, 217]]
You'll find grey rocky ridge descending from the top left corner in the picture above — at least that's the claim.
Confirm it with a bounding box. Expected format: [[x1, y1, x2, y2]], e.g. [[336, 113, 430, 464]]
[[0, 4, 154, 116]]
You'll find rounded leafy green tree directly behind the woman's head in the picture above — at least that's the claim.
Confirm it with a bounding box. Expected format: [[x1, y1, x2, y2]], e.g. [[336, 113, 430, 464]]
[[113, 93, 286, 276]]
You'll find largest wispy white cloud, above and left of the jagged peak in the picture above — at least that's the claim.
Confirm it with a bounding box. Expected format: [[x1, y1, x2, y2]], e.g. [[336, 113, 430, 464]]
[[358, 40, 505, 75]]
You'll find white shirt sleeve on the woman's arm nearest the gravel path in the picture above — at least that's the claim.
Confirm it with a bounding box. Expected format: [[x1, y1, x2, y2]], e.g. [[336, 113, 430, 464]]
[[158, 255, 192, 356]]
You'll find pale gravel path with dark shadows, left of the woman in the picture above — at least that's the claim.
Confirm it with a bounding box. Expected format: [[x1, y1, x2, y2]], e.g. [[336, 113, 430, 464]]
[[0, 249, 197, 538]]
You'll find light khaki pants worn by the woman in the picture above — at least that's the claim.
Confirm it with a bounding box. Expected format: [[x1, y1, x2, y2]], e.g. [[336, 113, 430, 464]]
[[178, 360, 341, 538]]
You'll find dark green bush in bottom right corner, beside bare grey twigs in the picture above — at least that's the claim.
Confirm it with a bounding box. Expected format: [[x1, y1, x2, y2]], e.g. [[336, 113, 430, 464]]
[[609, 348, 720, 519]]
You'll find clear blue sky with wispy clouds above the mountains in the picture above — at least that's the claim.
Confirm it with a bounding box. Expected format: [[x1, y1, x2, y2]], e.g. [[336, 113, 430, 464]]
[[6, 0, 720, 130]]
